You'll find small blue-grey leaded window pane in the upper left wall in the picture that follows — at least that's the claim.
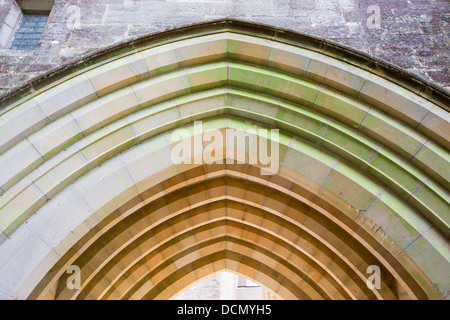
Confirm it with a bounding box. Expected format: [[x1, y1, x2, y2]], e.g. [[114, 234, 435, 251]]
[[10, 13, 48, 50]]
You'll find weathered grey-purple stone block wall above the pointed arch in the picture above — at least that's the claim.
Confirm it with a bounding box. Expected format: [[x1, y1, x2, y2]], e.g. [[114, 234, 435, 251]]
[[0, 0, 450, 97]]
